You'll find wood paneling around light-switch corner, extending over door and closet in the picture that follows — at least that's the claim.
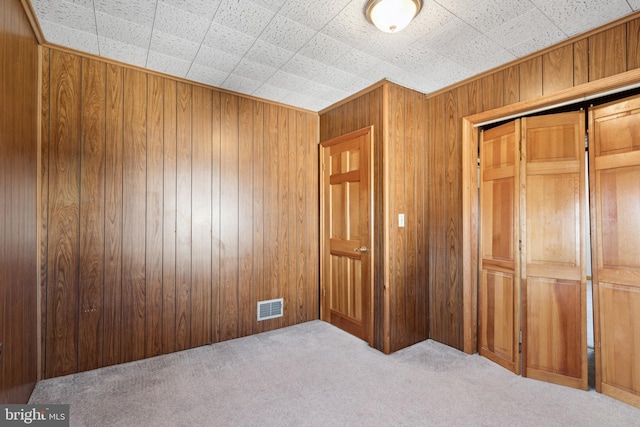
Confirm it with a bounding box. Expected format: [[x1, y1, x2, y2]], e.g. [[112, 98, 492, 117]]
[[320, 13, 640, 351]]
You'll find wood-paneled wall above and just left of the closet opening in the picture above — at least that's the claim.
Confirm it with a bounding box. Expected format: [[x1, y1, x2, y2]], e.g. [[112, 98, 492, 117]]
[[426, 13, 640, 349]]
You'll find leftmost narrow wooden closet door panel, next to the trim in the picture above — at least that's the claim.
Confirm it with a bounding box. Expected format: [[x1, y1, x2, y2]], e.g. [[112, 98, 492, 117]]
[[478, 120, 520, 374]]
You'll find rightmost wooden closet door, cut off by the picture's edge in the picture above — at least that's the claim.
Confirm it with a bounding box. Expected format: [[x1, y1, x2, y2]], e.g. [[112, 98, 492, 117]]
[[589, 96, 640, 407]]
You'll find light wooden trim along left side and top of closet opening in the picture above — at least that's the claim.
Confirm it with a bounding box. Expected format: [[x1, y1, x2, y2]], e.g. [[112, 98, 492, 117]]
[[462, 69, 640, 354]]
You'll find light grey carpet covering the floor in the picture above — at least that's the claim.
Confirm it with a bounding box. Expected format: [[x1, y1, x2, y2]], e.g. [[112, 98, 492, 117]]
[[29, 321, 640, 427]]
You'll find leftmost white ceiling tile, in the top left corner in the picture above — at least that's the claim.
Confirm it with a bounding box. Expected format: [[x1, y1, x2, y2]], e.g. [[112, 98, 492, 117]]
[[31, 0, 96, 35]]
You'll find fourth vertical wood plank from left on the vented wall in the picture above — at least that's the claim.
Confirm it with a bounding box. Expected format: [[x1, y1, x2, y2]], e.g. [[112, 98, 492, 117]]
[[121, 69, 147, 362]]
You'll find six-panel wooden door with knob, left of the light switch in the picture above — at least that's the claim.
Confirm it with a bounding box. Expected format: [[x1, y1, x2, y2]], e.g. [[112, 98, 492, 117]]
[[320, 128, 373, 345]]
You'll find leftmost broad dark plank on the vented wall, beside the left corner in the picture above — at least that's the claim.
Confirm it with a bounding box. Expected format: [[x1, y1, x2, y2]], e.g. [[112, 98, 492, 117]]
[[46, 51, 81, 376]]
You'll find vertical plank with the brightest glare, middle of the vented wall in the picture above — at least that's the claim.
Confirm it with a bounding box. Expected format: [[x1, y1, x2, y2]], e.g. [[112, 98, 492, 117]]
[[191, 86, 214, 347]]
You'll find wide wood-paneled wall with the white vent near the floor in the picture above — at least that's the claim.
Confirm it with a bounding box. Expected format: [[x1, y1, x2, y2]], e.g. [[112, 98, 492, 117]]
[[41, 48, 319, 377]]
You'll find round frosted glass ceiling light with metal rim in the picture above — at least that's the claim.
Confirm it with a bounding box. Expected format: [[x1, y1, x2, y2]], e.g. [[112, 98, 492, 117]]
[[365, 0, 422, 33]]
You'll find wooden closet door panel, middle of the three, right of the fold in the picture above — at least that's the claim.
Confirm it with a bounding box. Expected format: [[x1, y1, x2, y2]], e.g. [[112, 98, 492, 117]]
[[521, 111, 588, 390]]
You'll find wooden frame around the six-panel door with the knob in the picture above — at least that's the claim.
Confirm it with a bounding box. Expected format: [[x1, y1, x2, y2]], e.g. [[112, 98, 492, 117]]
[[318, 125, 376, 347]]
